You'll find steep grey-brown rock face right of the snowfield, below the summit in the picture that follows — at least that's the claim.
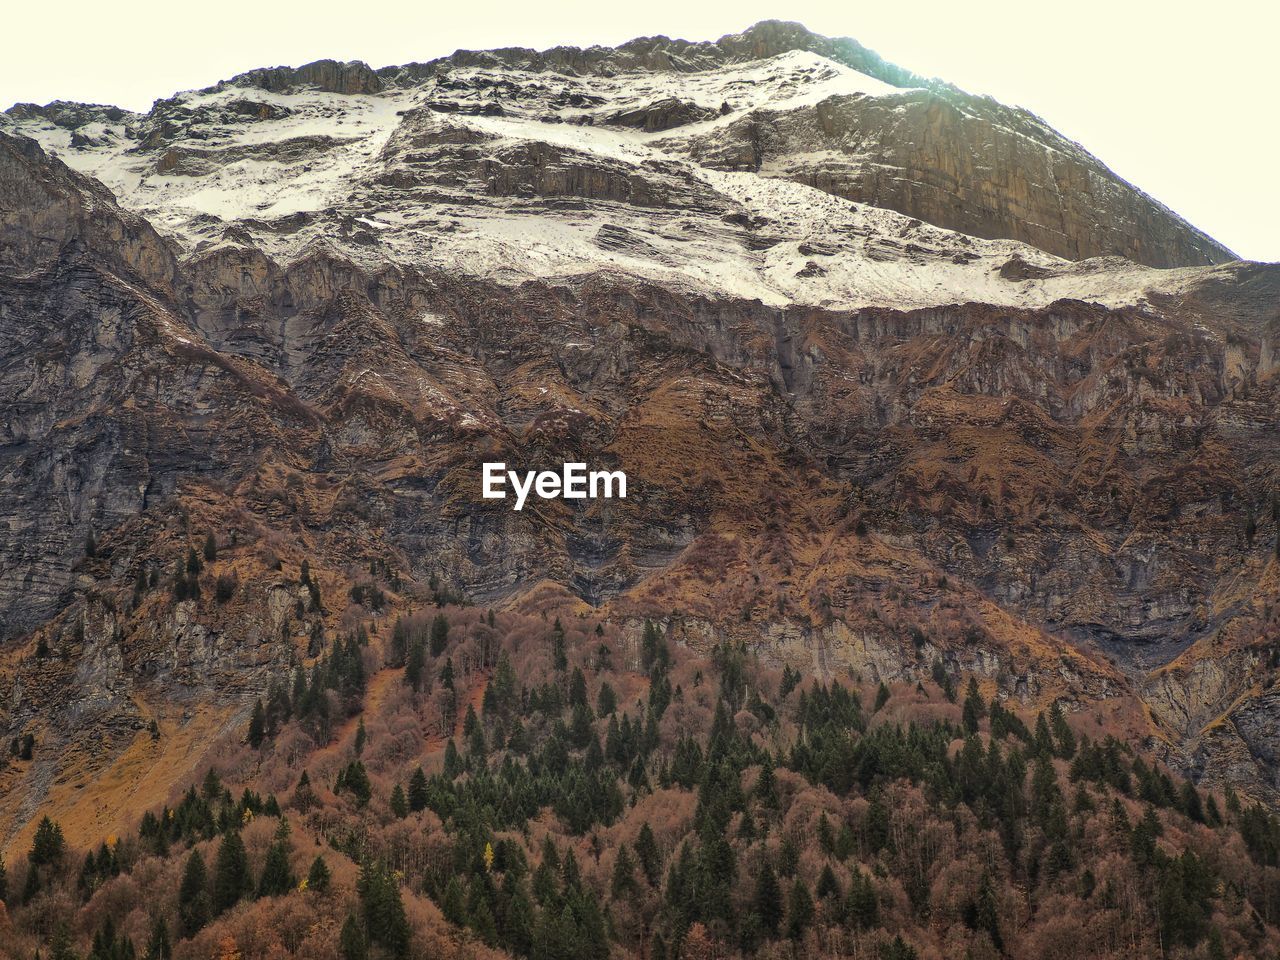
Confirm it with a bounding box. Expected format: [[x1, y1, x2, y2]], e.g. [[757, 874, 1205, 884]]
[[686, 88, 1234, 266]]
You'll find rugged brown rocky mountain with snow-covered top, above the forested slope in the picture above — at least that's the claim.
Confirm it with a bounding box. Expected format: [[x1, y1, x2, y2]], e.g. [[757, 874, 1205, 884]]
[[0, 22, 1280, 960]]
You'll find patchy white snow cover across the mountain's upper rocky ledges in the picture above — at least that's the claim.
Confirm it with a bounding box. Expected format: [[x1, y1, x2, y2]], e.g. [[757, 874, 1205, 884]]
[[6, 50, 1239, 308]]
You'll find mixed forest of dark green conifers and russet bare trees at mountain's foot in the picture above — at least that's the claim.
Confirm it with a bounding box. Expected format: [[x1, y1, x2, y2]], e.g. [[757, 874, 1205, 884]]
[[0, 605, 1280, 960]]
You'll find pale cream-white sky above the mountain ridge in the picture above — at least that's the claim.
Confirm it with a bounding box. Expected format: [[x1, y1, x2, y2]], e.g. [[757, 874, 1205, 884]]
[[0, 0, 1280, 260]]
